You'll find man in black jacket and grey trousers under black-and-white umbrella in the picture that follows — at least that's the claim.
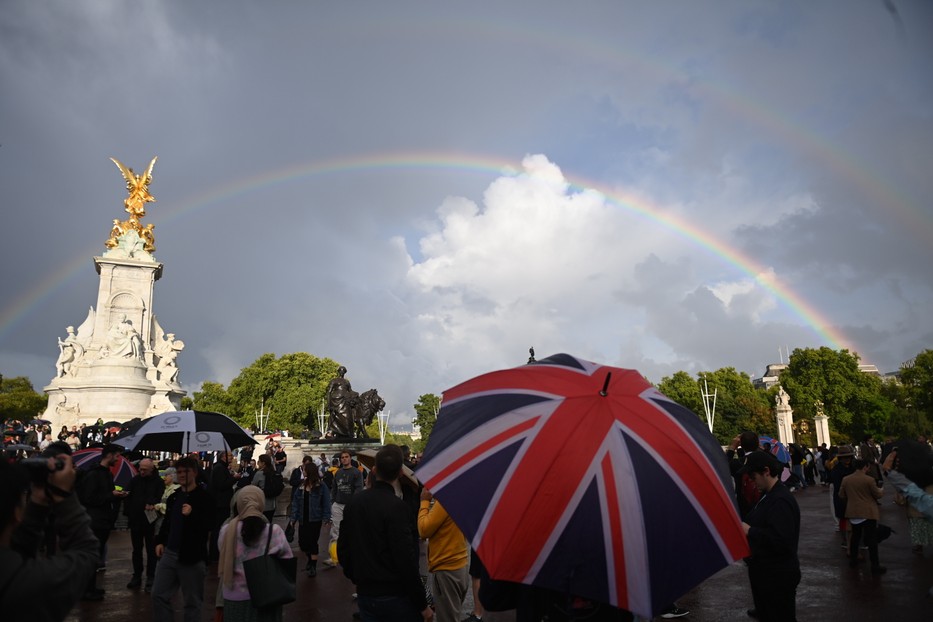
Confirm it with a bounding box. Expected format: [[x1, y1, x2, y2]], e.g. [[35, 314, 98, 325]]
[[152, 457, 214, 622]]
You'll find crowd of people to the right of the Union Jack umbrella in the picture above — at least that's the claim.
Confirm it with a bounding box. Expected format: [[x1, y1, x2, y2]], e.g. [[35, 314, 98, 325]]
[[726, 431, 933, 621]]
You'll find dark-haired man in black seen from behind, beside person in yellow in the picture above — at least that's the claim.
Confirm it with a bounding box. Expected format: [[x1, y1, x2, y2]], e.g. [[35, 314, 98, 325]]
[[337, 445, 434, 622]]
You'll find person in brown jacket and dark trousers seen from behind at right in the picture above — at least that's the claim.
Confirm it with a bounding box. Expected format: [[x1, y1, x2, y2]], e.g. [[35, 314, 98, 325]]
[[839, 458, 887, 575]]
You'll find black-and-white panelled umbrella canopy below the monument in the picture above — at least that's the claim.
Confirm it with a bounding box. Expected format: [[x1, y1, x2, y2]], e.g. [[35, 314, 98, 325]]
[[111, 410, 256, 453]]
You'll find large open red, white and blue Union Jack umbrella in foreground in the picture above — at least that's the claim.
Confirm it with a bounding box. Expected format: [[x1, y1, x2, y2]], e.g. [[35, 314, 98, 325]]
[[417, 354, 749, 618]]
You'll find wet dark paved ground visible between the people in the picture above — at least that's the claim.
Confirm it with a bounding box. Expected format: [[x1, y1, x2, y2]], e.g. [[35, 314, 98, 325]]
[[67, 486, 933, 622]]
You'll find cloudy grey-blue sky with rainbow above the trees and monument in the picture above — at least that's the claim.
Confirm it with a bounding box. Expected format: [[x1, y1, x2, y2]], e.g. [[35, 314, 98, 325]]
[[0, 0, 933, 427]]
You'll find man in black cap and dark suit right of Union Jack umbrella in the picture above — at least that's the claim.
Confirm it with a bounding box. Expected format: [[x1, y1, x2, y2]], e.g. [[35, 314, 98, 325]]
[[742, 451, 800, 622]]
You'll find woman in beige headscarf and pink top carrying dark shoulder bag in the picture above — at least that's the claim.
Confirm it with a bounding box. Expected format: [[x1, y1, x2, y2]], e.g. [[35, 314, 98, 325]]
[[218, 485, 293, 622]]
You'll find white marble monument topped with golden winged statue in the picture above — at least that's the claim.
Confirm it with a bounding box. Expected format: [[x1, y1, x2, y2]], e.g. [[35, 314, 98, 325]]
[[43, 158, 185, 429]]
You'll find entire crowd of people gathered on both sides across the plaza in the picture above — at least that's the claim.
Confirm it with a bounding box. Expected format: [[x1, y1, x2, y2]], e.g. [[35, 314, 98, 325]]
[[0, 414, 933, 622]]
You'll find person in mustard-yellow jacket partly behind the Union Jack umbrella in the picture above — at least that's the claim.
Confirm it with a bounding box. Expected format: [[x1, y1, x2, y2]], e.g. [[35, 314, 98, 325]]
[[418, 488, 470, 622]]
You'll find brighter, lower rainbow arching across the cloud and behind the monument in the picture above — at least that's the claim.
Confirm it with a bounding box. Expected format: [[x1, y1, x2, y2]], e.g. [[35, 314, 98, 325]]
[[0, 153, 856, 352]]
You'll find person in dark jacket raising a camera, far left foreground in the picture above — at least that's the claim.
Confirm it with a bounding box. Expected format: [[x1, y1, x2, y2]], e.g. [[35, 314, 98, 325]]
[[0, 453, 98, 621]]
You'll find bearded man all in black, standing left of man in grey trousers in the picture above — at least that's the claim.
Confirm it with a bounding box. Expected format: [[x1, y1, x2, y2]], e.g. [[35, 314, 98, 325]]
[[123, 458, 165, 592]]
